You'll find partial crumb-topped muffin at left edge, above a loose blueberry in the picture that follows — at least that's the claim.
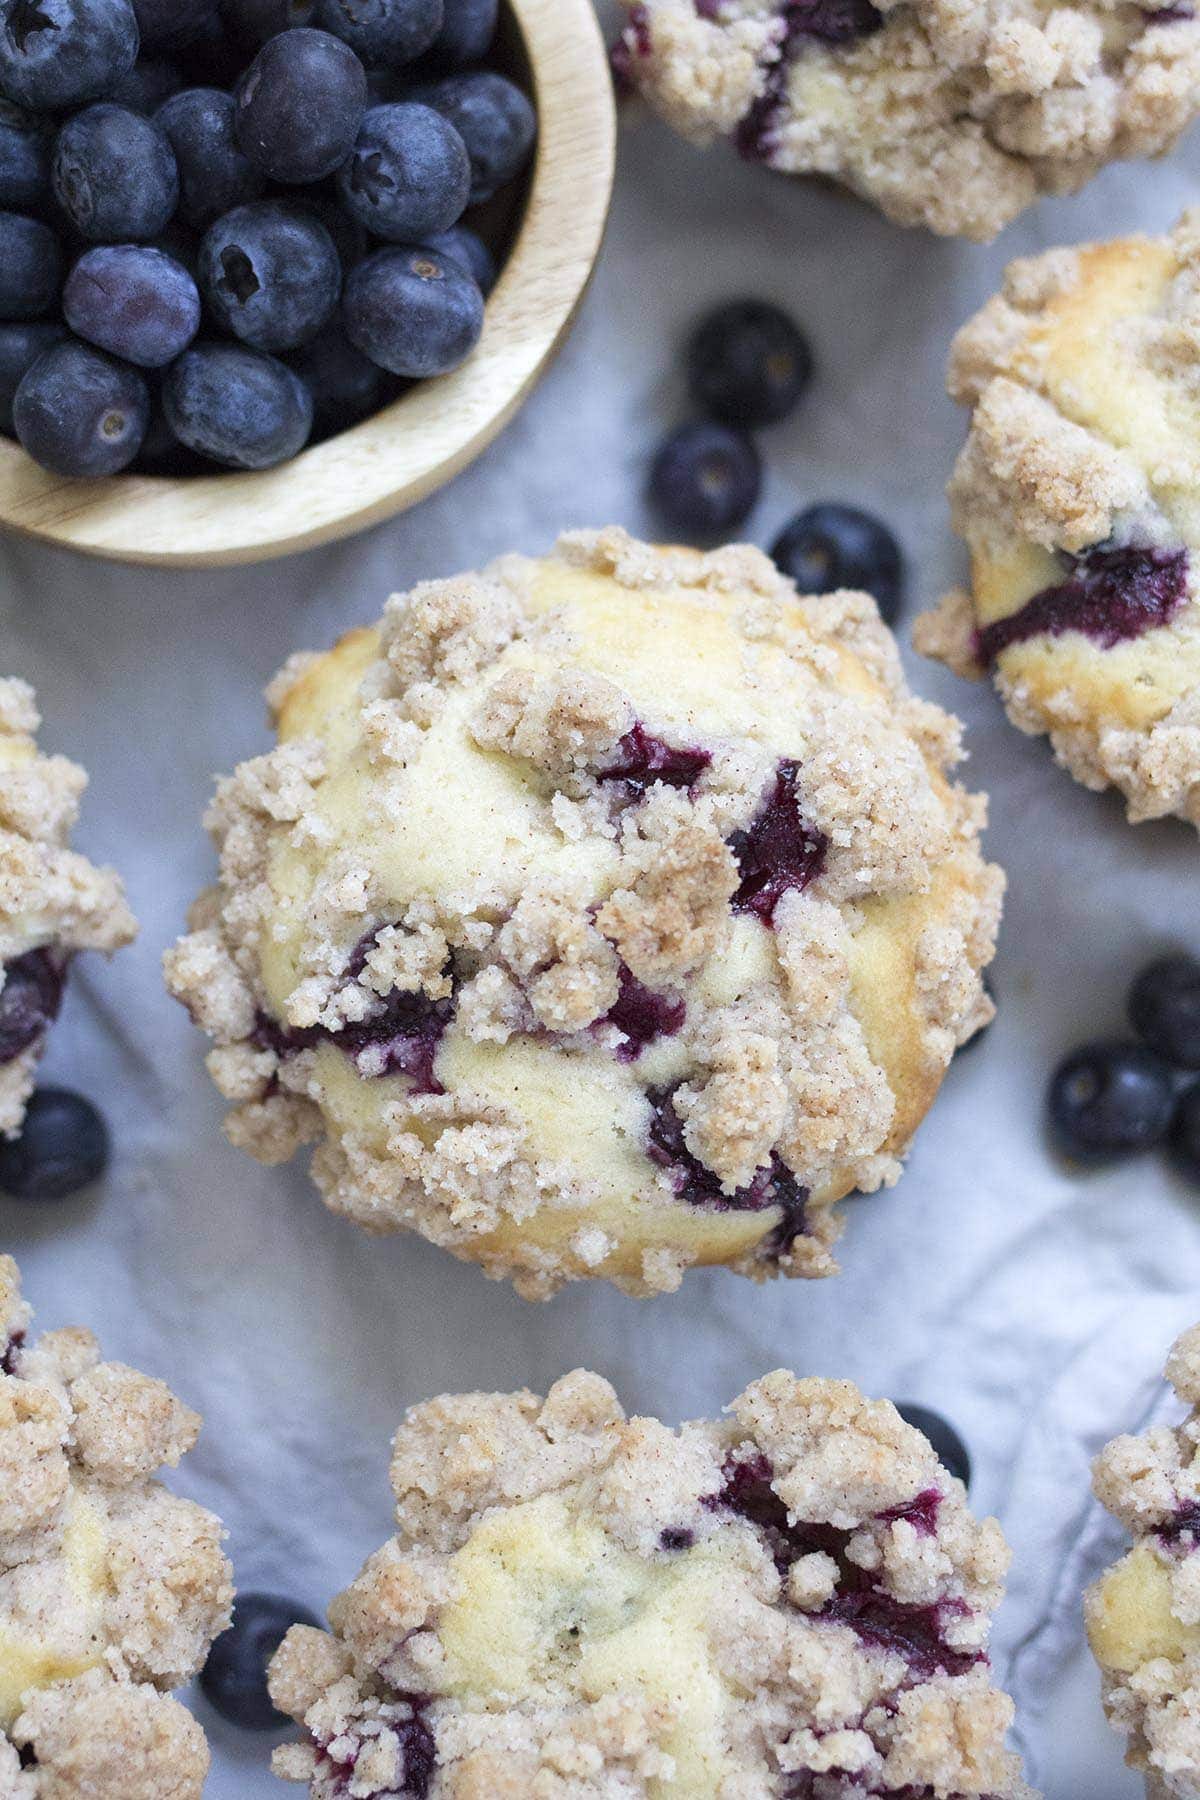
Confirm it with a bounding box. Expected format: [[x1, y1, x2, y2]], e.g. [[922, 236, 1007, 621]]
[[0, 679, 137, 1136]]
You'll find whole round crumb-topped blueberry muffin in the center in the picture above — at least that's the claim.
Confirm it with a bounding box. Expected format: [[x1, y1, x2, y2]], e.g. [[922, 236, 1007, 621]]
[[166, 531, 1002, 1298]]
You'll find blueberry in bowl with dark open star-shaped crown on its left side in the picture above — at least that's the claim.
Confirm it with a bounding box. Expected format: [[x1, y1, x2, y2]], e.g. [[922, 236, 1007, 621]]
[[200, 200, 342, 351]]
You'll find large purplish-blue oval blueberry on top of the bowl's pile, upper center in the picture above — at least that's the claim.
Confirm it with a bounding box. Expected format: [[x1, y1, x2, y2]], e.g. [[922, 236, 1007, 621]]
[[234, 29, 367, 184]]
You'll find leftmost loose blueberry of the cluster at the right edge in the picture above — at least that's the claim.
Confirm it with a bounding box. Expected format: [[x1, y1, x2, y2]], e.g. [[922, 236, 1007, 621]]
[[1049, 1042, 1175, 1161]]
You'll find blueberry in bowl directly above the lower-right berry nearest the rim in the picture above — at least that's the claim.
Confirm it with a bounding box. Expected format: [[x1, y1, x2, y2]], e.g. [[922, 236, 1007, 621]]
[[338, 104, 471, 243]]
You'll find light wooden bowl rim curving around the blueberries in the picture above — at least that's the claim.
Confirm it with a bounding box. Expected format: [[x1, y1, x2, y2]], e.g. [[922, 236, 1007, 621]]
[[0, 0, 615, 569]]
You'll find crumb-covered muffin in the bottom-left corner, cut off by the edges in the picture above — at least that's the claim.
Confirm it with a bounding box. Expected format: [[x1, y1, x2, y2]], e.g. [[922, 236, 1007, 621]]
[[0, 1256, 232, 1800]]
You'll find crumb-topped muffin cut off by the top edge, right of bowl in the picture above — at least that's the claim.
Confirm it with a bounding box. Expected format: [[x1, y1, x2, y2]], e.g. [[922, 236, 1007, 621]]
[[617, 0, 1200, 239]]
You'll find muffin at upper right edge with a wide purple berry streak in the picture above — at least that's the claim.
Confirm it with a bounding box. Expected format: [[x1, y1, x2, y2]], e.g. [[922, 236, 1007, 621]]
[[916, 211, 1200, 824]]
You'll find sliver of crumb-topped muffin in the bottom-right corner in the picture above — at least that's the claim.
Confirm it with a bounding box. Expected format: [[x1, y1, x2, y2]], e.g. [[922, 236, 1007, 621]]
[[1087, 1325, 1200, 1800]]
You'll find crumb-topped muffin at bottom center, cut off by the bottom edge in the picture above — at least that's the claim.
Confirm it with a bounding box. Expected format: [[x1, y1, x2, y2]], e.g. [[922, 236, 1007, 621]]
[[270, 1370, 1033, 1800]]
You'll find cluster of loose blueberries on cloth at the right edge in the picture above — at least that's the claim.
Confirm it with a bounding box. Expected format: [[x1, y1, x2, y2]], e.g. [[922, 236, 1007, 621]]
[[1049, 956, 1200, 1186]]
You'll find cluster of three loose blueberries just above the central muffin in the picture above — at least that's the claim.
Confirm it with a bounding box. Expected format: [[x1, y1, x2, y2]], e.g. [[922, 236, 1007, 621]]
[[649, 301, 903, 625]]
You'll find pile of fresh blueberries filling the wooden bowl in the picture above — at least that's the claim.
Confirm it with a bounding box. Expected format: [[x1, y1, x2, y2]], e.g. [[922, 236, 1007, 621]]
[[0, 0, 536, 475]]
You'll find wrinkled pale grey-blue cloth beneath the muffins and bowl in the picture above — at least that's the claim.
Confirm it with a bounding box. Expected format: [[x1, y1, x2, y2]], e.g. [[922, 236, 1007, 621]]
[[0, 10, 1200, 1800]]
